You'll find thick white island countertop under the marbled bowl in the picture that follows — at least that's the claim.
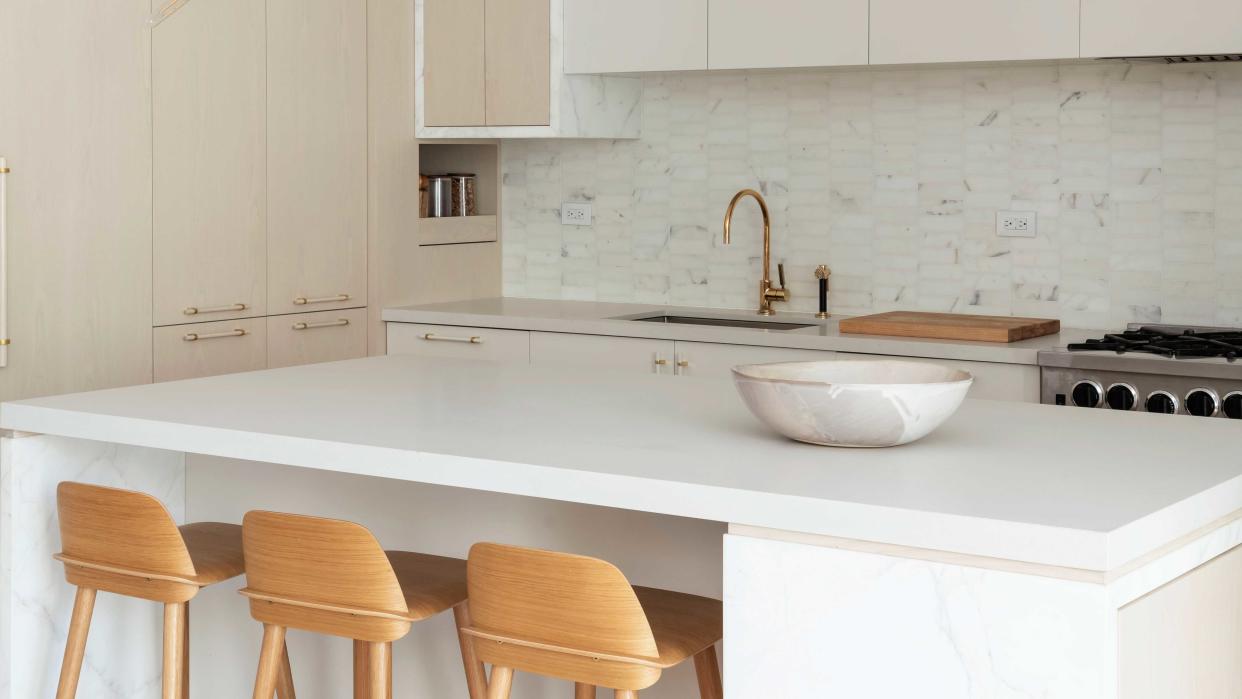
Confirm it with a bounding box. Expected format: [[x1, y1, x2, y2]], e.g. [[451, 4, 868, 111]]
[[0, 356, 1242, 571]]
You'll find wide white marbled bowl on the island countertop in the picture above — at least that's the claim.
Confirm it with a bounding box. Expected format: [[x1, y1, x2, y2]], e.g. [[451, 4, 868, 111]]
[[733, 360, 974, 447]]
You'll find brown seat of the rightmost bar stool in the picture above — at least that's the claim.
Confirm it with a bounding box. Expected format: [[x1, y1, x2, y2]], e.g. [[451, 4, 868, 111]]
[[633, 585, 724, 669]]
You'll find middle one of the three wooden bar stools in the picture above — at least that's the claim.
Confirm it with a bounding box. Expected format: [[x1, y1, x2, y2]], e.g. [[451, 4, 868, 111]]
[[241, 512, 487, 699]]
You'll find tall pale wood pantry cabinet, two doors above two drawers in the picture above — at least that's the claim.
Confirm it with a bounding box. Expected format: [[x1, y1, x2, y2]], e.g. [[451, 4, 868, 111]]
[[152, 0, 368, 381]]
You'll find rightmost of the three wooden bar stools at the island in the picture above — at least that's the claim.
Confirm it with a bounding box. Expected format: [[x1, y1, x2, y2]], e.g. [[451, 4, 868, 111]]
[[462, 544, 724, 699]]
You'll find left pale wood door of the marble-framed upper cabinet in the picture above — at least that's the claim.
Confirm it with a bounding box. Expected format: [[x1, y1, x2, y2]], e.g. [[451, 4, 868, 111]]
[[422, 0, 487, 127]]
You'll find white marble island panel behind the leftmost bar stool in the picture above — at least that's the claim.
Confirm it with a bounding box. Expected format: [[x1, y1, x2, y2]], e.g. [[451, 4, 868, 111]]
[[0, 436, 185, 699]]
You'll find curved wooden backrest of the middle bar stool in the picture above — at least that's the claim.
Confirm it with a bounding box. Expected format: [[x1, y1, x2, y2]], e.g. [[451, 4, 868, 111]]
[[241, 512, 411, 643]]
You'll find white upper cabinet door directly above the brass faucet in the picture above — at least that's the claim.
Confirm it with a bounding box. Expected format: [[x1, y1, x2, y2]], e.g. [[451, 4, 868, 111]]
[[707, 0, 868, 70]]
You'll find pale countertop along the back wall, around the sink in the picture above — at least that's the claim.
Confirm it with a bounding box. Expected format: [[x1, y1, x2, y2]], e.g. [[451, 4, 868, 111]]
[[384, 298, 1103, 365]]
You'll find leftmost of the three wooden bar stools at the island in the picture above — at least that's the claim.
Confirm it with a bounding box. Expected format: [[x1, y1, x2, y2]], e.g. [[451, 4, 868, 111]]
[[56, 482, 293, 699]]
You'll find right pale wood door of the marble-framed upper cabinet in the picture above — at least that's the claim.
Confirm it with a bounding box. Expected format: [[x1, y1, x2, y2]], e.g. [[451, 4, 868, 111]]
[[483, 0, 551, 127]]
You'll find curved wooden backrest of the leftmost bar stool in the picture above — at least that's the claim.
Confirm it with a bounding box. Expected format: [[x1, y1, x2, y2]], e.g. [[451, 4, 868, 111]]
[[56, 482, 200, 603]]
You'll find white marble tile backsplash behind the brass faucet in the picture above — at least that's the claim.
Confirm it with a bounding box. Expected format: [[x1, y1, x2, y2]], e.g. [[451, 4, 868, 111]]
[[502, 62, 1242, 328]]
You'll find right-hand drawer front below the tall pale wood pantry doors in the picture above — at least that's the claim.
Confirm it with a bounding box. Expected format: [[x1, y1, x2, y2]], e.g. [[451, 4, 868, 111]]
[[267, 308, 366, 369]]
